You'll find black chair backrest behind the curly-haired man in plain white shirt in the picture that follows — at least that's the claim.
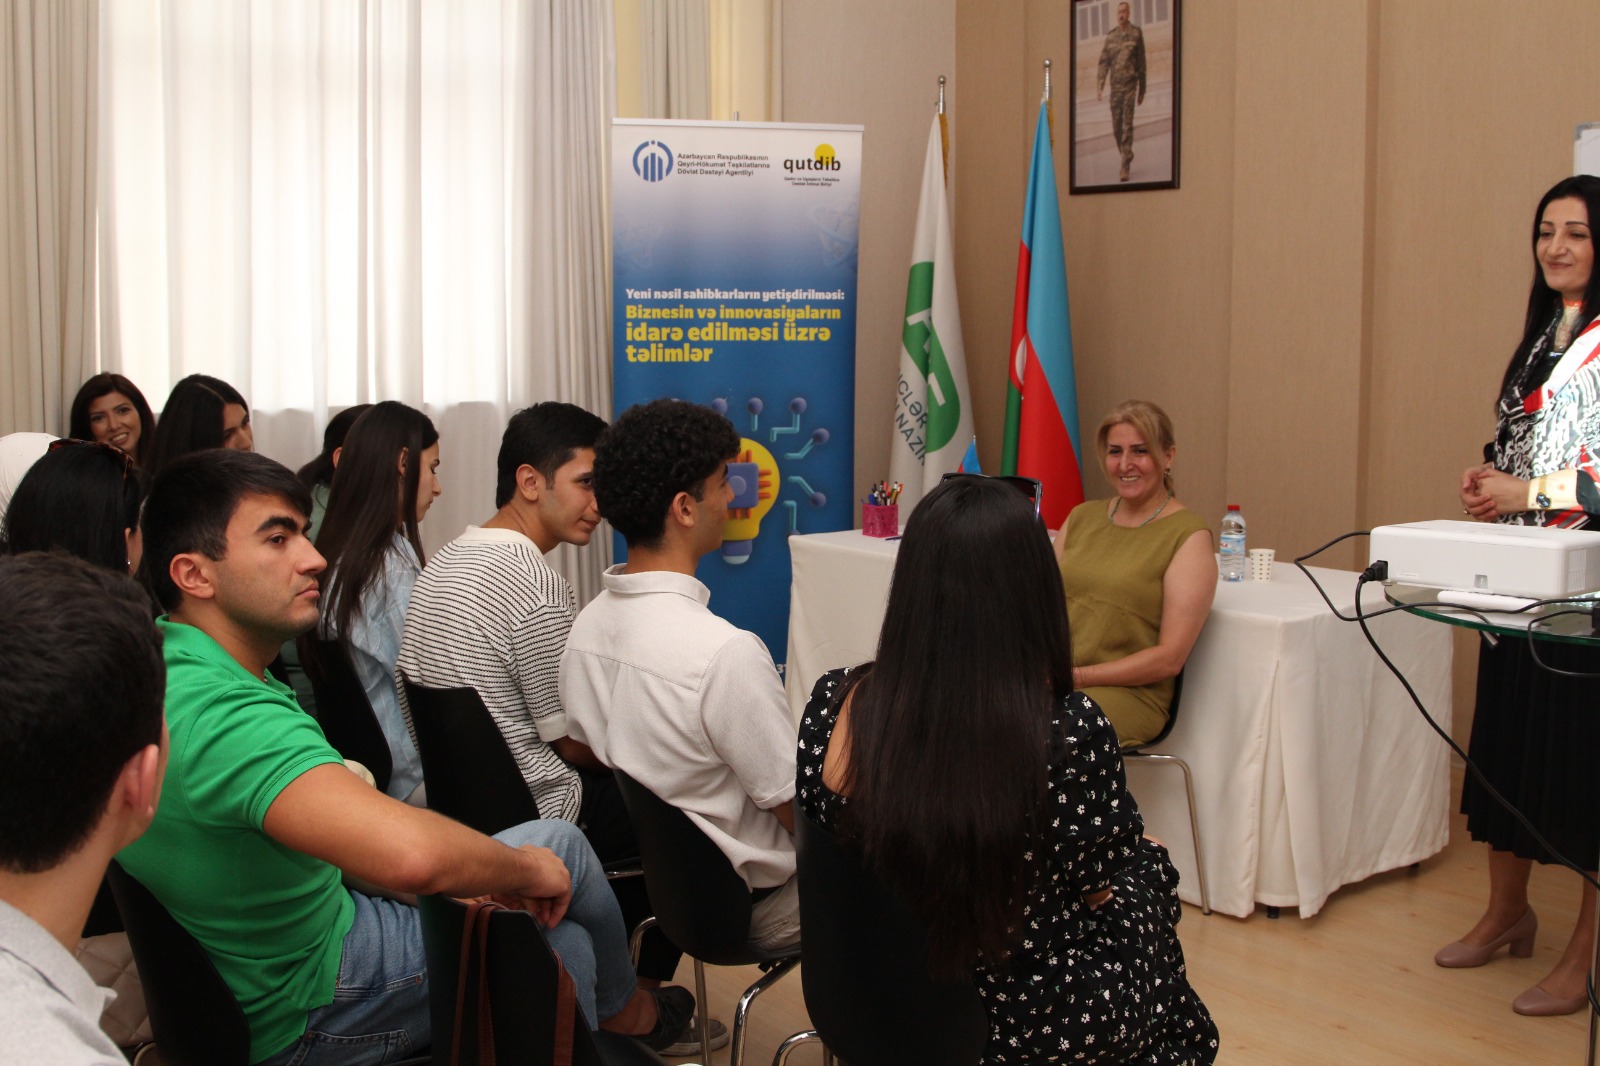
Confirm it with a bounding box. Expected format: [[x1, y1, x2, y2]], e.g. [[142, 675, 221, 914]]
[[614, 770, 750, 965]]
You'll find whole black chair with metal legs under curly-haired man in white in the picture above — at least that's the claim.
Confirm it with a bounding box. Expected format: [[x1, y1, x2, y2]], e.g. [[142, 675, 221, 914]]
[[614, 770, 800, 1066]]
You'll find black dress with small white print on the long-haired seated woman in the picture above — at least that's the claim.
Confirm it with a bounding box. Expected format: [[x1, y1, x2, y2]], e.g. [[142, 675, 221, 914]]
[[797, 671, 1218, 1066]]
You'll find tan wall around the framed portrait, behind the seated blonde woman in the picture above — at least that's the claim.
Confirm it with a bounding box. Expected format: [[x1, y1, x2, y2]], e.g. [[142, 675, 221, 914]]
[[952, 0, 1600, 723]]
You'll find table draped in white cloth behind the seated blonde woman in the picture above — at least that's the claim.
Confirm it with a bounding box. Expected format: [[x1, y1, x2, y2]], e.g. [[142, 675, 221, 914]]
[[786, 530, 1451, 917]]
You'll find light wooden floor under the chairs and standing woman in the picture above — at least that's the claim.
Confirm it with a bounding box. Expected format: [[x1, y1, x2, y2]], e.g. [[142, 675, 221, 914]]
[[678, 771, 1589, 1066]]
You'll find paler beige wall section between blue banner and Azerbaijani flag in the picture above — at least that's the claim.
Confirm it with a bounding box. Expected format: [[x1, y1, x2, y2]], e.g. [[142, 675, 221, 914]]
[[782, 0, 953, 505]]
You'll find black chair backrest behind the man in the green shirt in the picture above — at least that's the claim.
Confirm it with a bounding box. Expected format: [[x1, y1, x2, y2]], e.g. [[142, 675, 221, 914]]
[[106, 863, 250, 1066]]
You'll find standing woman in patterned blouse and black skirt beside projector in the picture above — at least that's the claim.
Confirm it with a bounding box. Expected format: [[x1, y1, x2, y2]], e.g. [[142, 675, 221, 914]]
[[1434, 174, 1600, 1015]]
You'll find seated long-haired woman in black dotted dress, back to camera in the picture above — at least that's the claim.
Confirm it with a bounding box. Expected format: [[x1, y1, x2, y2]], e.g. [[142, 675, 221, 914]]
[[798, 477, 1218, 1066]]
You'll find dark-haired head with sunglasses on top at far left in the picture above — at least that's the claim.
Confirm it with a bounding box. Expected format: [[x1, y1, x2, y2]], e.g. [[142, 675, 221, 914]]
[[0, 440, 144, 573]]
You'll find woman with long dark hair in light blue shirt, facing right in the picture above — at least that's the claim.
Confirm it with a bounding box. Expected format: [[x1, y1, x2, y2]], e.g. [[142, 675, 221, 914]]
[[317, 400, 440, 805]]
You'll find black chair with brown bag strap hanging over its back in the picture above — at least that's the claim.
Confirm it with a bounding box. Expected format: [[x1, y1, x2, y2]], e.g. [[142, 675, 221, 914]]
[[418, 896, 662, 1066]]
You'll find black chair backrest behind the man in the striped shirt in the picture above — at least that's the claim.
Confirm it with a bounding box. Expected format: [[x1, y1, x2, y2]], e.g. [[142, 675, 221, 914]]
[[400, 674, 539, 834]]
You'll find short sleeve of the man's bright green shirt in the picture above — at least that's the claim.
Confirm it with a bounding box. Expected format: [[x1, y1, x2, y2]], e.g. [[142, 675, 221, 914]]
[[181, 675, 344, 829]]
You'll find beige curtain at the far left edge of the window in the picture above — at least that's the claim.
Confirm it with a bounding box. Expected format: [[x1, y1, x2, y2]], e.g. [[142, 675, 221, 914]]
[[0, 0, 99, 434]]
